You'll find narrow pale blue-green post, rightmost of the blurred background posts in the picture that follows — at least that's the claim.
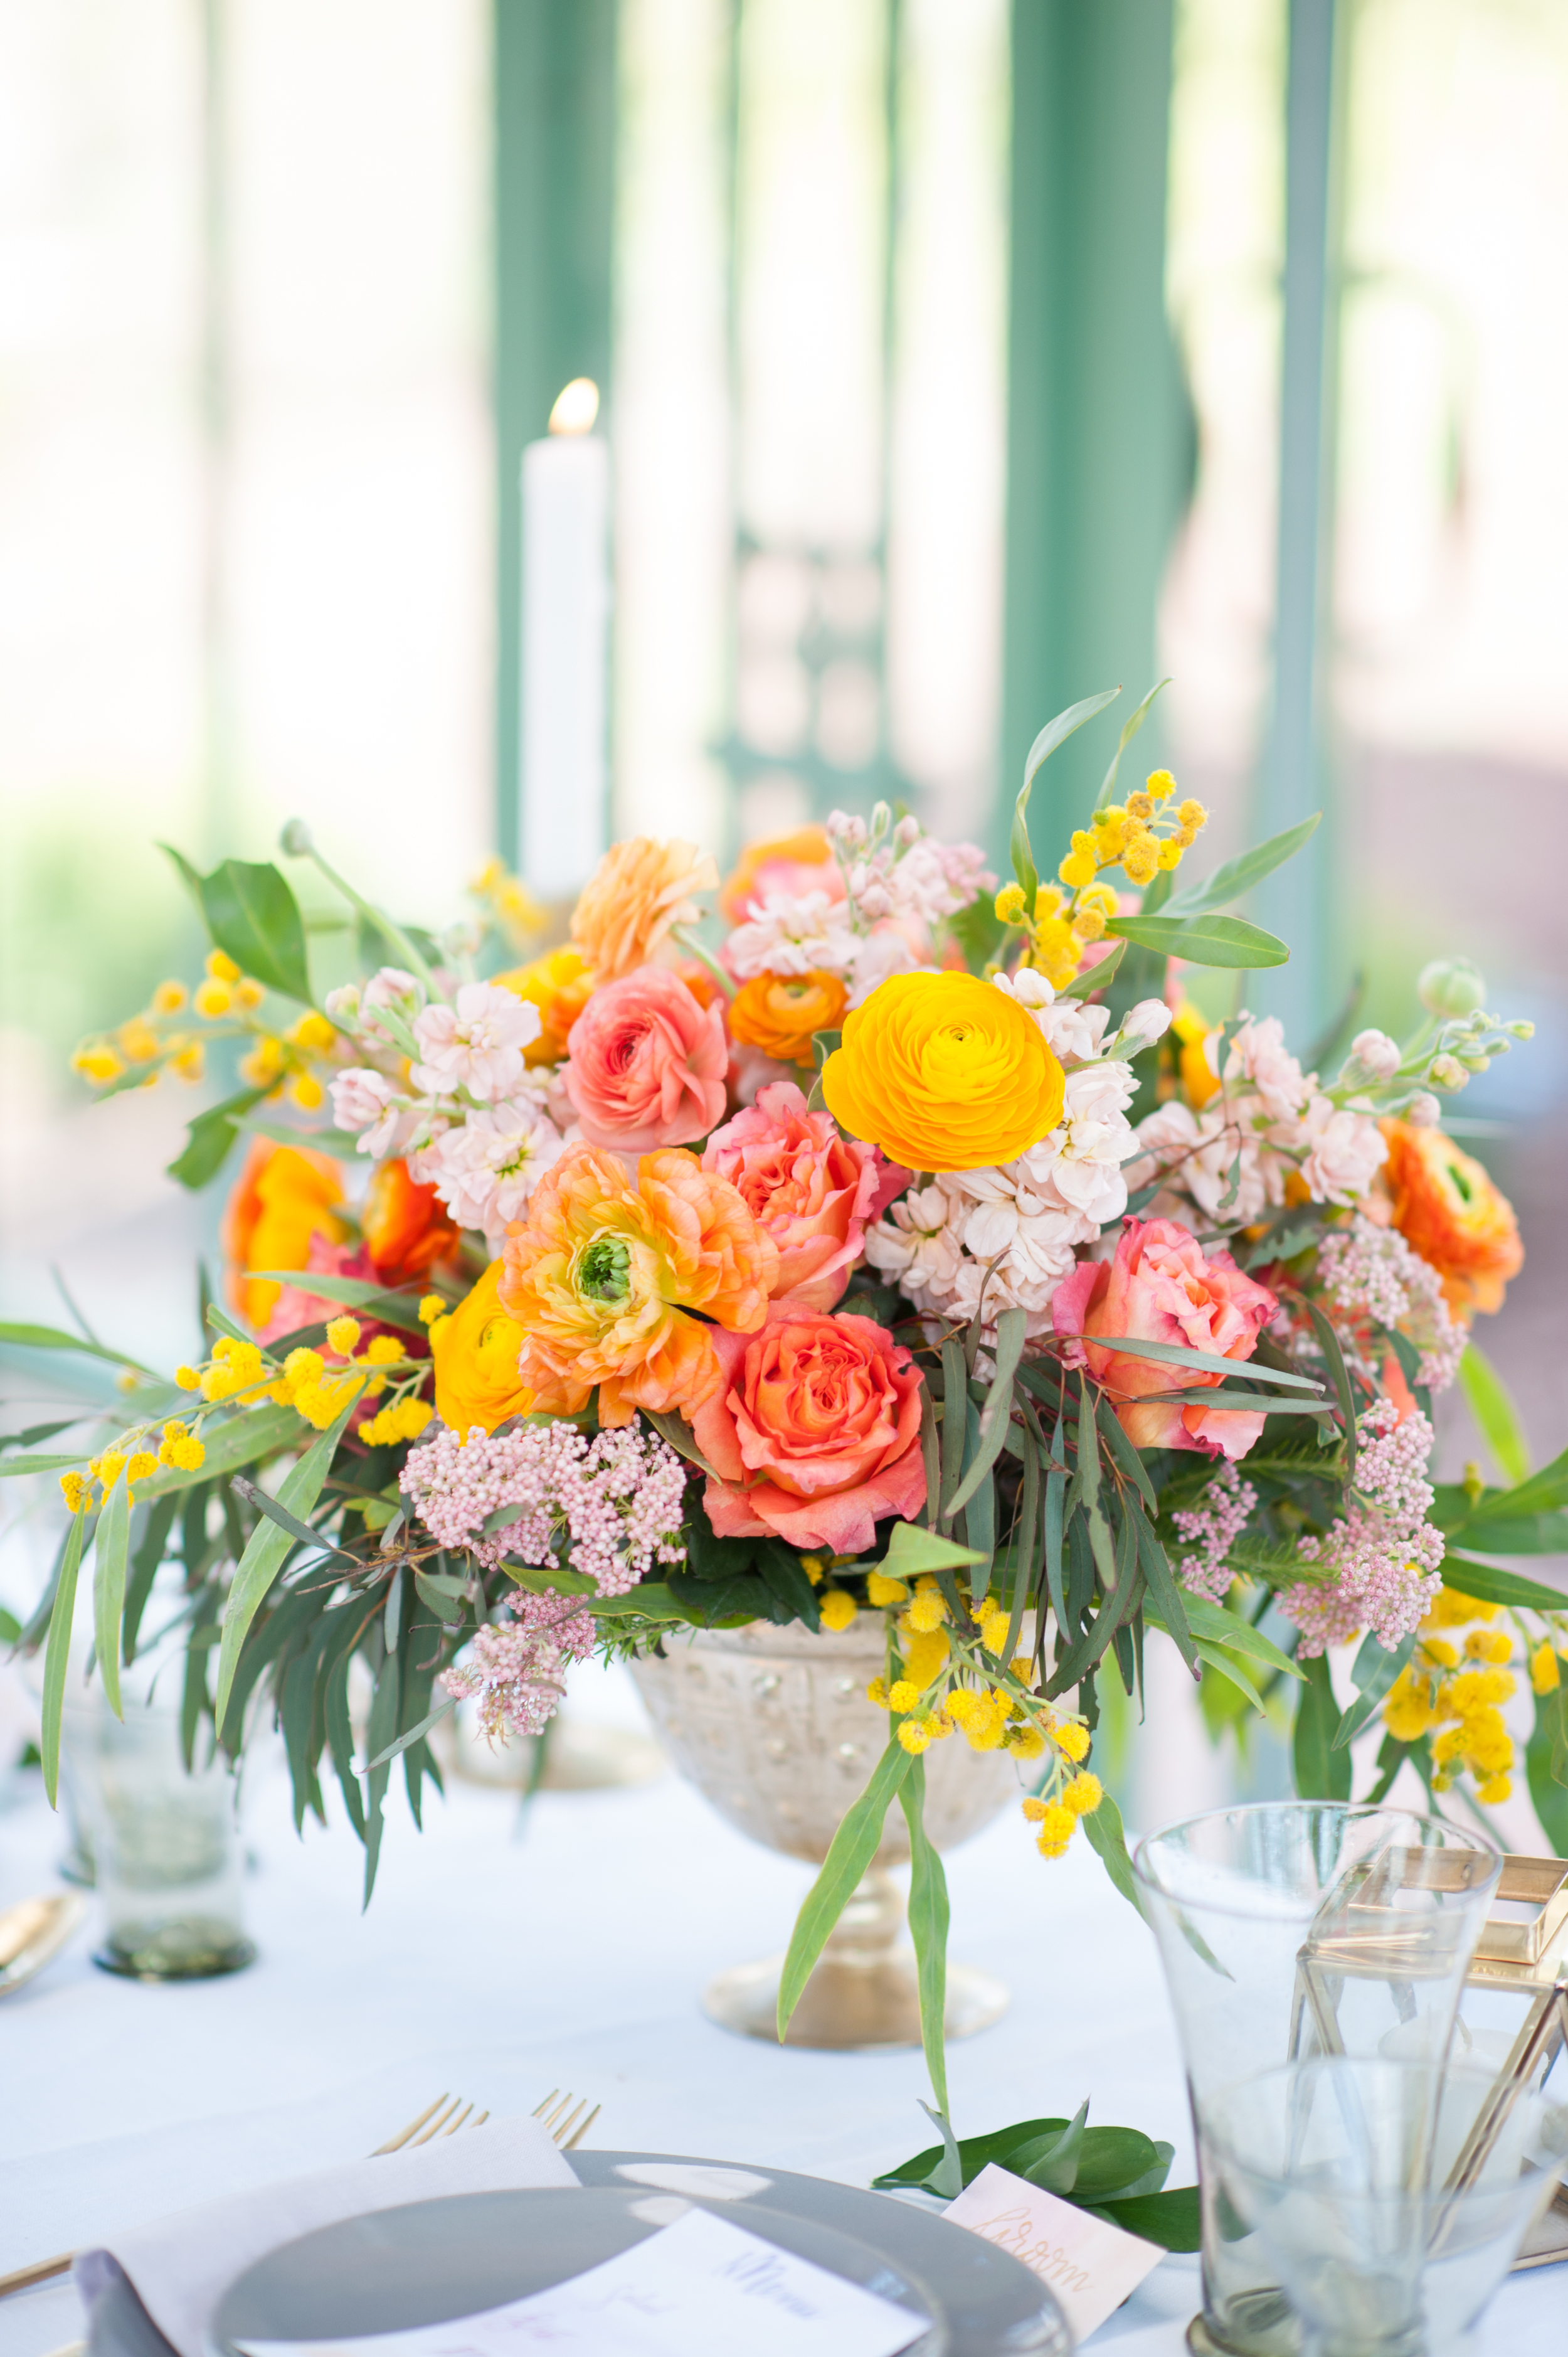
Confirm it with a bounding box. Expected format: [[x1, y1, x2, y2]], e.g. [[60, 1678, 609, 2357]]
[[1248, 0, 1344, 1053]]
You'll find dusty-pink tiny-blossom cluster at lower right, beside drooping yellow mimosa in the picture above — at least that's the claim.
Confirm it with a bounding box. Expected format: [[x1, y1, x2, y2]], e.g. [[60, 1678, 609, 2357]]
[[1278, 1400, 1443, 1659]]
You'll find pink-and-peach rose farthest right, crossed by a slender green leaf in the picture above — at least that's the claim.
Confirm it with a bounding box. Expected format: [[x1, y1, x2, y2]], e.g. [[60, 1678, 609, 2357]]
[[1052, 1218, 1278, 1457]]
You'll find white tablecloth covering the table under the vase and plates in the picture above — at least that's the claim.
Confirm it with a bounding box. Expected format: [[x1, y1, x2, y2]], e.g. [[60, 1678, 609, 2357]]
[[0, 1688, 1568, 2357]]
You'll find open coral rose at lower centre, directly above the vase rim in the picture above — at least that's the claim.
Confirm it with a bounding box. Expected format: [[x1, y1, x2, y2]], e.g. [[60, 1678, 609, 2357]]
[[691, 1304, 926, 1556]]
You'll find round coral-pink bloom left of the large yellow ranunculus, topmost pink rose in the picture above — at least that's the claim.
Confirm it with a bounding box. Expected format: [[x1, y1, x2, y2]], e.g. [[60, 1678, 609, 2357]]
[[566, 966, 729, 1155]]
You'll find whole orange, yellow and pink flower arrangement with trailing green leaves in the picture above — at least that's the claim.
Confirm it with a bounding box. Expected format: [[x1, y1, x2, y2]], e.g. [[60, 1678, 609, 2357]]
[[7, 698, 1568, 2112]]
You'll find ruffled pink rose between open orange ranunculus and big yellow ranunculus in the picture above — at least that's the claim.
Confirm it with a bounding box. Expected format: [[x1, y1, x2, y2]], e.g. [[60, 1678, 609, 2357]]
[[702, 1080, 910, 1311]]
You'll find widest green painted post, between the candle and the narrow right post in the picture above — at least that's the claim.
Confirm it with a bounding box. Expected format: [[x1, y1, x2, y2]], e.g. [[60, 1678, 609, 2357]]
[[990, 0, 1193, 875]]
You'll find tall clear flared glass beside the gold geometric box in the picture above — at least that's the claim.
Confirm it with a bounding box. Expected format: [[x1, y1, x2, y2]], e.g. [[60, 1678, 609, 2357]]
[[1134, 1801, 1502, 2357]]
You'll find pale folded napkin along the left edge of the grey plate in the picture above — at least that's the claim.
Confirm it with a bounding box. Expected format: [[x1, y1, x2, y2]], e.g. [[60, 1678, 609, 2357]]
[[78, 2119, 578, 2357]]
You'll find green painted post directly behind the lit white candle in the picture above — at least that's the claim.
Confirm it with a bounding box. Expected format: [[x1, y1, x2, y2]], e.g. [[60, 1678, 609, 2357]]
[[490, 0, 615, 865]]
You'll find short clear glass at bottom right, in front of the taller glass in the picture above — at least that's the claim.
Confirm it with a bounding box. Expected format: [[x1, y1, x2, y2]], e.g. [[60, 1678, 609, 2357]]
[[1210, 2055, 1568, 2357]]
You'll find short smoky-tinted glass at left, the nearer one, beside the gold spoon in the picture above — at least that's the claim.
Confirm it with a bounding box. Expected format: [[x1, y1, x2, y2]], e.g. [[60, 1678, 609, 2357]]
[[92, 1693, 255, 1980]]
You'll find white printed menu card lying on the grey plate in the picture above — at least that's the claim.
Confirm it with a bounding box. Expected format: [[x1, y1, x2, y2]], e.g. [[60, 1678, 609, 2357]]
[[240, 2208, 929, 2357]]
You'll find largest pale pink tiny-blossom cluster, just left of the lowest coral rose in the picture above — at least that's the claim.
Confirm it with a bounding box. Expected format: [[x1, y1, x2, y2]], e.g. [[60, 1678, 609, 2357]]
[[403, 1423, 686, 1595]]
